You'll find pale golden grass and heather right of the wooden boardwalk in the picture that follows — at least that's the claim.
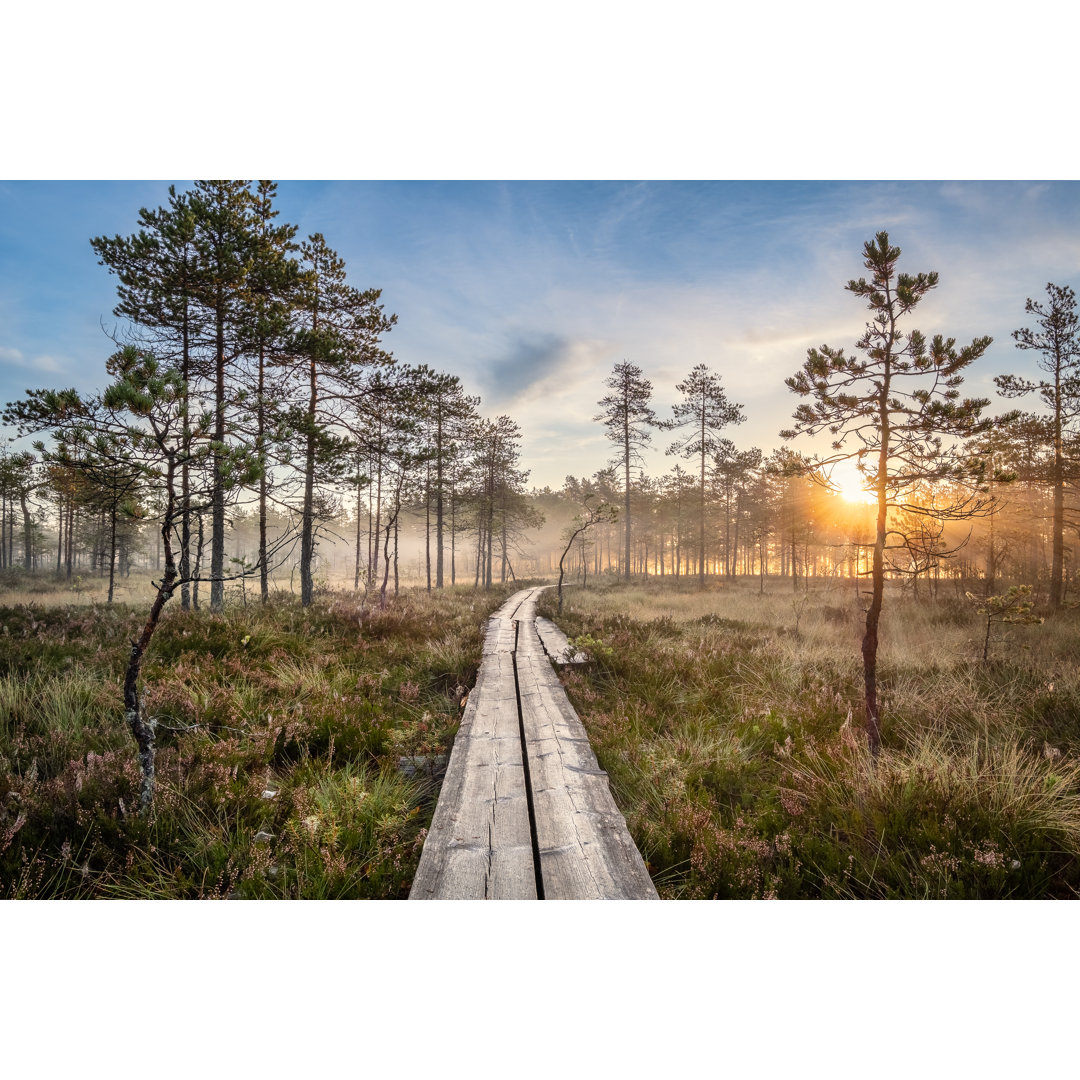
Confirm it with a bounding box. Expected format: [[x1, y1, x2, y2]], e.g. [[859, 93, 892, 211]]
[[542, 582, 1080, 899]]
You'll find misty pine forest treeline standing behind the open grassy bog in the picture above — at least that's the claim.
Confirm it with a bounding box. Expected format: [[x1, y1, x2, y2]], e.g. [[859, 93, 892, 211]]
[[0, 192, 1080, 626]]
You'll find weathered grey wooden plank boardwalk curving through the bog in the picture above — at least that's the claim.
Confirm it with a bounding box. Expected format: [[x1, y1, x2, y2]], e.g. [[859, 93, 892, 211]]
[[409, 586, 657, 900]]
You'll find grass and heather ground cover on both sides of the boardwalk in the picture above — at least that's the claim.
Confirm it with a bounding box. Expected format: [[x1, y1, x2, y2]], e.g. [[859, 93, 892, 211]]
[[6, 580, 1080, 899]]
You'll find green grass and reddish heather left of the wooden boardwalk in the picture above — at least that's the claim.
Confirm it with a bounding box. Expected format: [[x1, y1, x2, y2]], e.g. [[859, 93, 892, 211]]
[[0, 582, 522, 899]]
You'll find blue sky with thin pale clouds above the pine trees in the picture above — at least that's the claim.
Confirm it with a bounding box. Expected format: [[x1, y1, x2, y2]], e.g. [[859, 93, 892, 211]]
[[0, 180, 1080, 485]]
